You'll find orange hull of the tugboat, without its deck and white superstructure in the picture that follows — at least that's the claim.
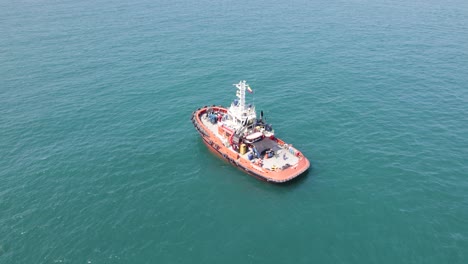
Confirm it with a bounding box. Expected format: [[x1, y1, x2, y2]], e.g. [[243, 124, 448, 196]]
[[191, 105, 310, 183]]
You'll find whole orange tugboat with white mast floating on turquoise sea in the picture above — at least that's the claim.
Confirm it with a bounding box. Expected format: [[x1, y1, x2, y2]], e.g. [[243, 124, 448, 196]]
[[191, 81, 310, 183]]
